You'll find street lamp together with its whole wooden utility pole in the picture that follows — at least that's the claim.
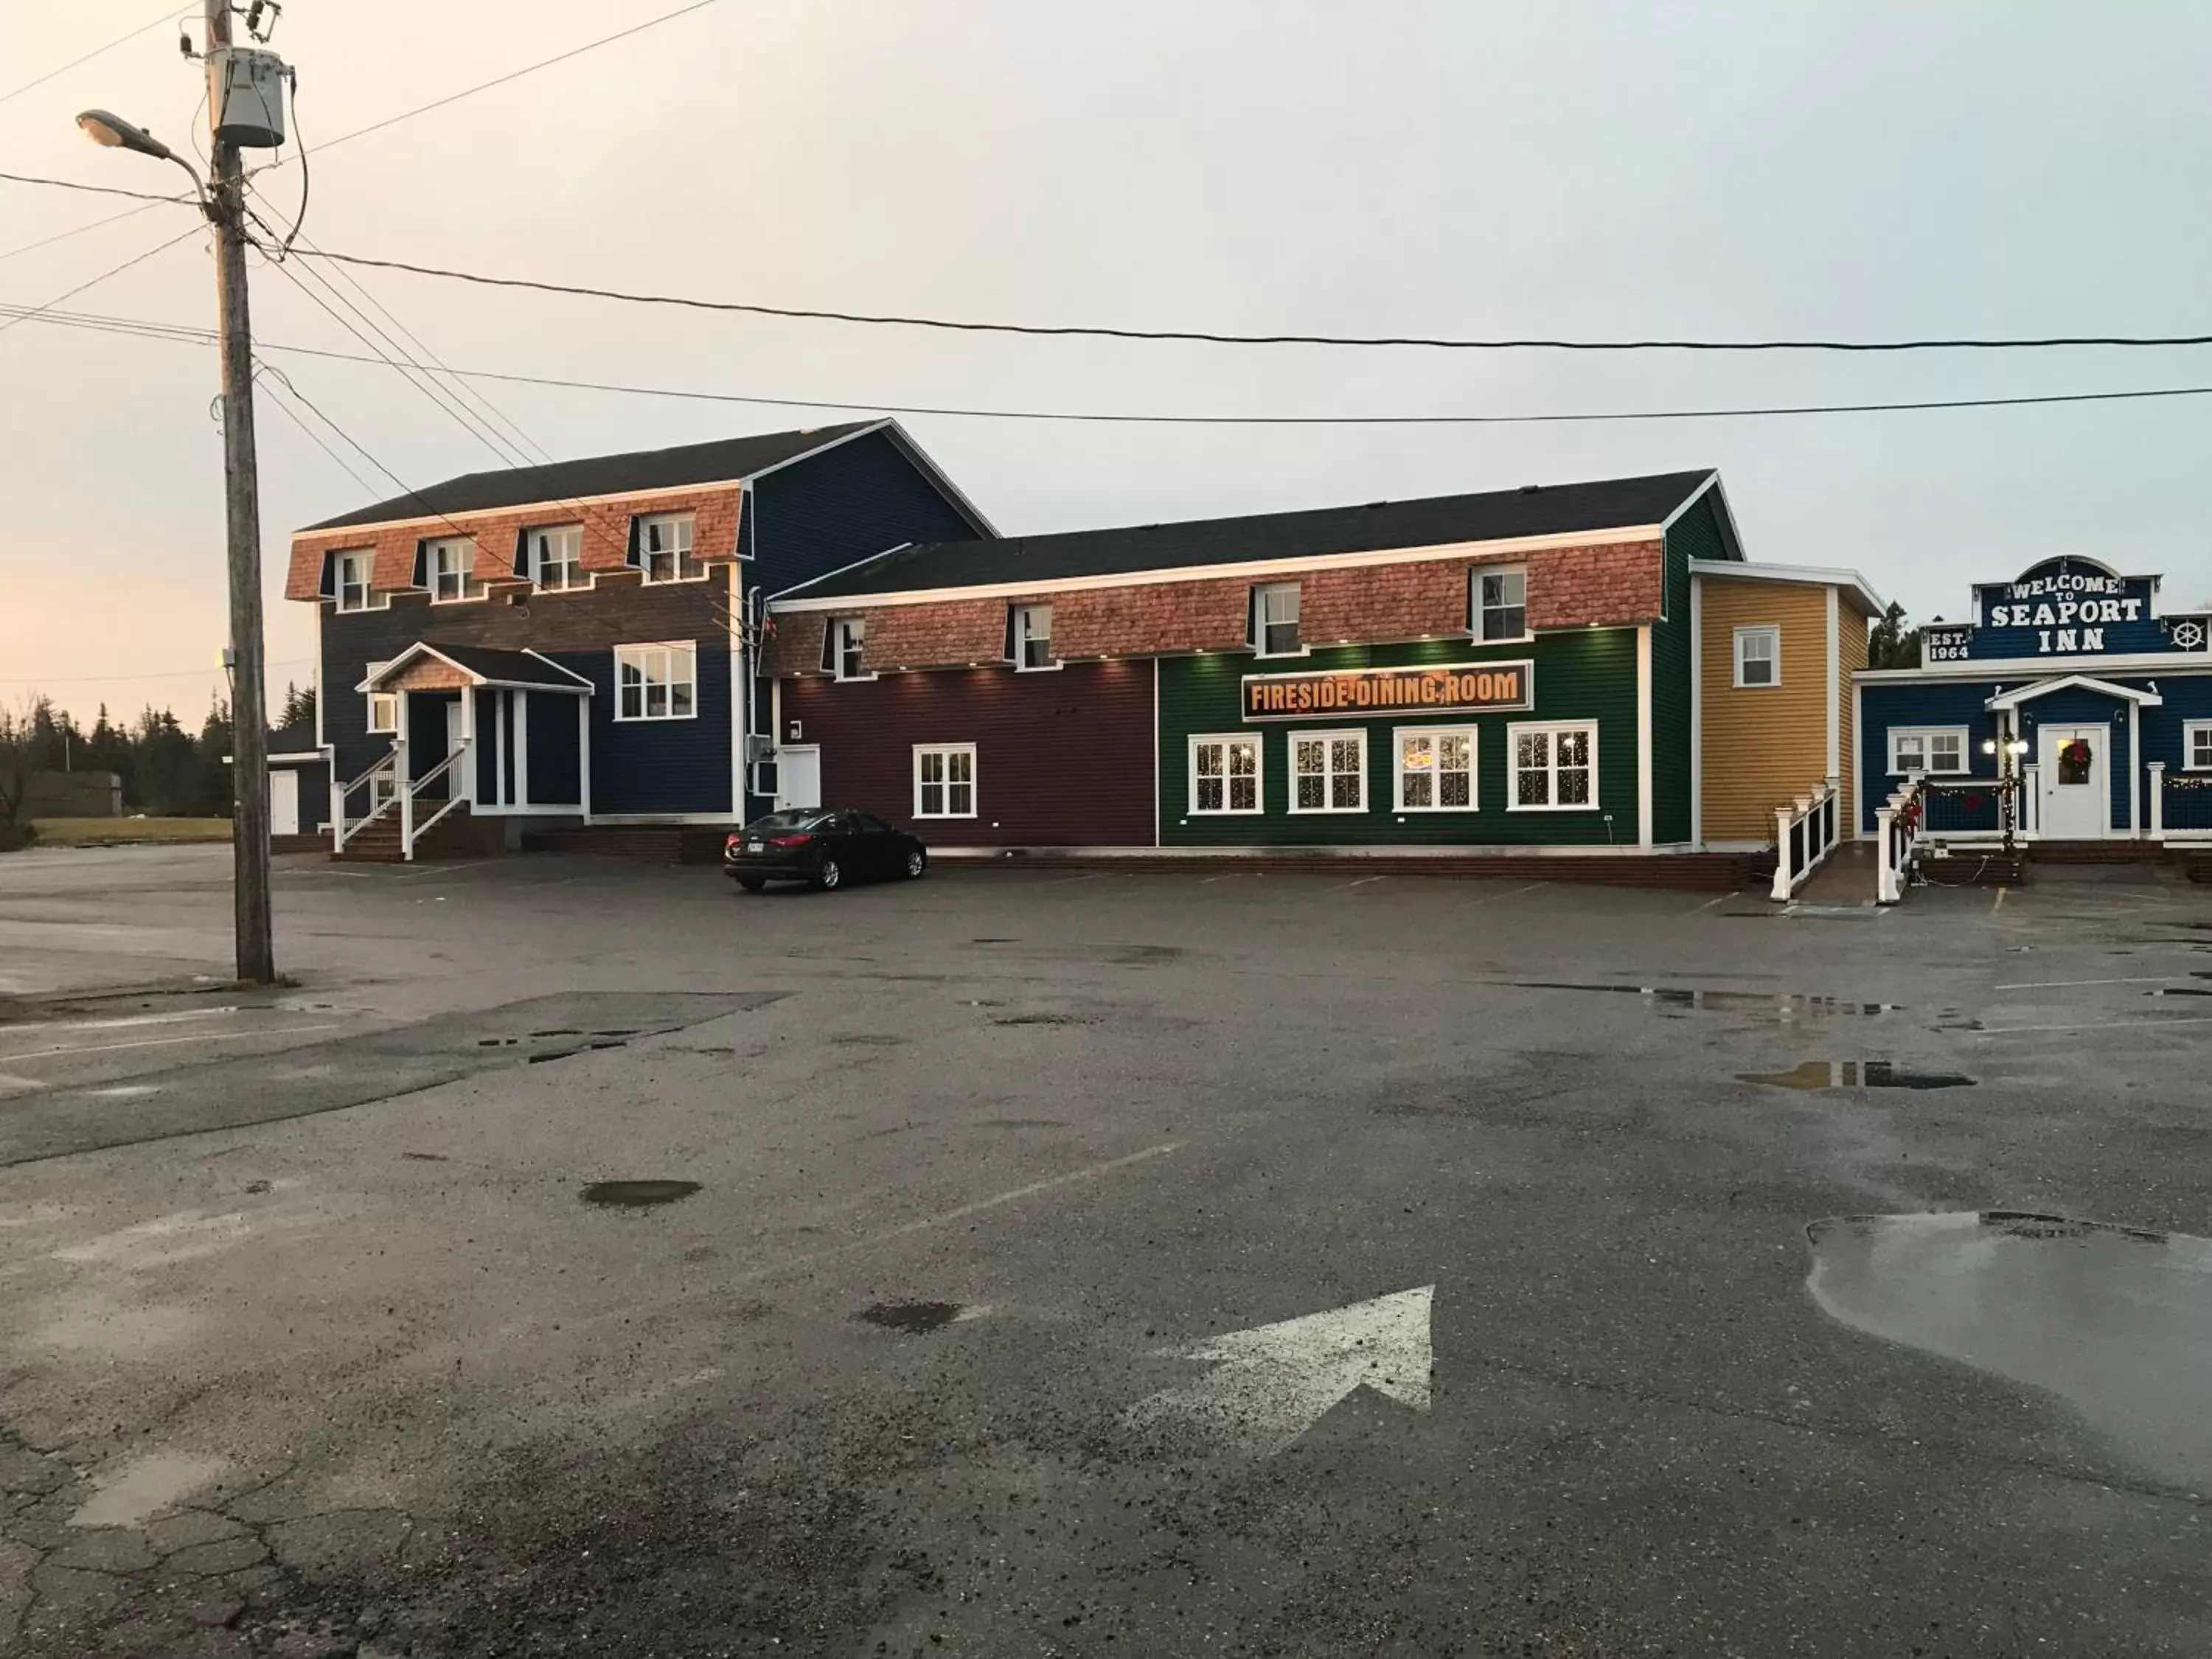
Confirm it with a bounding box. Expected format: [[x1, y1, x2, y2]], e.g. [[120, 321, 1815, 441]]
[[77, 0, 283, 984]]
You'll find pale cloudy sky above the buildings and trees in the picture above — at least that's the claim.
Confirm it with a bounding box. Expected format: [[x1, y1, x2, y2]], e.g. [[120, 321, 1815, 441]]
[[0, 0, 2212, 723]]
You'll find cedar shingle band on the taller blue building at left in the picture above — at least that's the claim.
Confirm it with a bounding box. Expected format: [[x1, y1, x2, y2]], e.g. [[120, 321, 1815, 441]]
[[283, 484, 739, 599]]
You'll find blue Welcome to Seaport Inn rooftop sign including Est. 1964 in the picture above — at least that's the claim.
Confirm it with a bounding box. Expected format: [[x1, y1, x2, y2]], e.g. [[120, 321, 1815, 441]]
[[1920, 557, 2208, 664]]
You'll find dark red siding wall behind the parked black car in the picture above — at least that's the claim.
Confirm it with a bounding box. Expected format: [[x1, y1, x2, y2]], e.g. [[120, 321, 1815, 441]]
[[783, 661, 1152, 847]]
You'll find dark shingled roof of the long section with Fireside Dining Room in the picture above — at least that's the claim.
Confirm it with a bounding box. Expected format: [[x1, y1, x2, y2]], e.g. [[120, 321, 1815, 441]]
[[792, 467, 1712, 599]]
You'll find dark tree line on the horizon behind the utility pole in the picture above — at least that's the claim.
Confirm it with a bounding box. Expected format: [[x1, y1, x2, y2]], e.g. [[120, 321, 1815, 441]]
[[0, 686, 314, 847]]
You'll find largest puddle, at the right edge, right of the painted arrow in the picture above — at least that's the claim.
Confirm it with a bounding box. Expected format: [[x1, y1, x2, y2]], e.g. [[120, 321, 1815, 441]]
[[1805, 1210, 2212, 1493]]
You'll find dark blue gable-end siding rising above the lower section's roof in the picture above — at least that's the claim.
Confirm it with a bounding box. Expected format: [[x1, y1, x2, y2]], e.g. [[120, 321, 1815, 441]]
[[743, 431, 982, 593]]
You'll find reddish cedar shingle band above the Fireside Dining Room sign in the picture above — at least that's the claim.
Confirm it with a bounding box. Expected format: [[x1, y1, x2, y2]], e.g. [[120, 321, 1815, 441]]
[[770, 542, 1663, 677]]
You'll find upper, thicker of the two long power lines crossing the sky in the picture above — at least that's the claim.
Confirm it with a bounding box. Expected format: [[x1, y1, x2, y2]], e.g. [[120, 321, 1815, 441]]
[[294, 246, 2212, 352]]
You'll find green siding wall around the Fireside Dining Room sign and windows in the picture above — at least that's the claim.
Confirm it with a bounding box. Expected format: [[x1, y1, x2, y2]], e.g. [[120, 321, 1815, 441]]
[[1159, 633, 1646, 847]]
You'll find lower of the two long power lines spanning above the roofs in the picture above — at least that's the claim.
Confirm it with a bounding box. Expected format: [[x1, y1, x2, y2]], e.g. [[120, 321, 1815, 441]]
[[21, 303, 2212, 427]]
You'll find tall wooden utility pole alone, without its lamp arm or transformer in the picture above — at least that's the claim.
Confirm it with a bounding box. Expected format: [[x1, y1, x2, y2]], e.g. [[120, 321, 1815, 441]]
[[206, 0, 276, 984]]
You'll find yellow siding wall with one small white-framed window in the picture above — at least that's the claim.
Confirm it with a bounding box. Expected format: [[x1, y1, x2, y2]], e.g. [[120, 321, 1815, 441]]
[[1699, 575, 1865, 841]]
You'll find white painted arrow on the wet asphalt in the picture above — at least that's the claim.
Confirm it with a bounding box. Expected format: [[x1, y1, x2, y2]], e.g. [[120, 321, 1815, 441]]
[[1124, 1285, 1436, 1458]]
